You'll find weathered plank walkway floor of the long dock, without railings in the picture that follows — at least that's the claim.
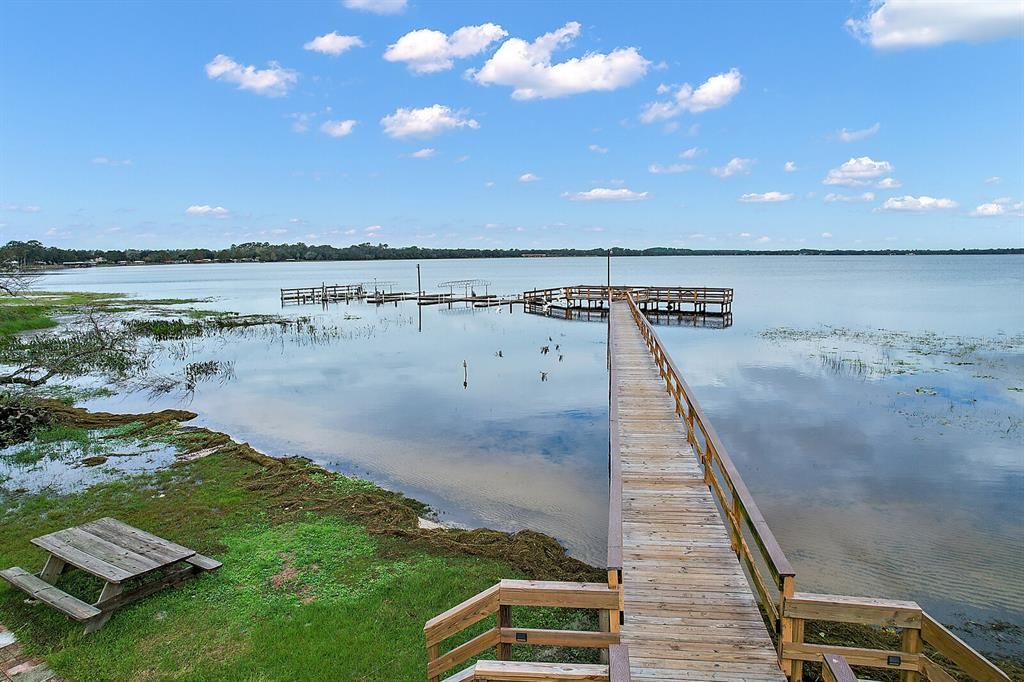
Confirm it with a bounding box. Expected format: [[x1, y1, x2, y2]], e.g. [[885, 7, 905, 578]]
[[611, 301, 784, 681]]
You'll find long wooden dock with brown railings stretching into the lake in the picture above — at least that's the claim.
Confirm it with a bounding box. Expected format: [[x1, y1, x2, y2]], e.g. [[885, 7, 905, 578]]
[[423, 287, 1010, 682]]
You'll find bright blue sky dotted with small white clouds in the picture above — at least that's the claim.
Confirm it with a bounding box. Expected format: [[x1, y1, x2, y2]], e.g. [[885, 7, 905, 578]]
[[0, 0, 1024, 249]]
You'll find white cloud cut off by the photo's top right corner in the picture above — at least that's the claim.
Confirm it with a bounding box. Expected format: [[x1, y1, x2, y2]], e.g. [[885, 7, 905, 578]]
[[846, 0, 1024, 49]]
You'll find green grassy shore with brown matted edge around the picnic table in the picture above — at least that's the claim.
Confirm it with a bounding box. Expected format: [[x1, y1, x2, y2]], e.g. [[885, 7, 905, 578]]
[[0, 404, 600, 681]]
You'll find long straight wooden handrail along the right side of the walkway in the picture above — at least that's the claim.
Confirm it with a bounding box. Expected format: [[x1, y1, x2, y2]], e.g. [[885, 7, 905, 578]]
[[626, 293, 796, 635]]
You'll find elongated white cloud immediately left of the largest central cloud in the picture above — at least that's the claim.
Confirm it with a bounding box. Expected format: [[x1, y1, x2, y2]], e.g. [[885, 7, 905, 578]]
[[384, 24, 508, 74]]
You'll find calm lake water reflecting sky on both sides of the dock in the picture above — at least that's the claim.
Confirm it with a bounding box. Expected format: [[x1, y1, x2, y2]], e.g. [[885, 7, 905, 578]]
[[22, 256, 1024, 652]]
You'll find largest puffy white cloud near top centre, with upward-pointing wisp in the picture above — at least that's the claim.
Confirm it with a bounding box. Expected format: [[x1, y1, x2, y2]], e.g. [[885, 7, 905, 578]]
[[467, 22, 650, 99]]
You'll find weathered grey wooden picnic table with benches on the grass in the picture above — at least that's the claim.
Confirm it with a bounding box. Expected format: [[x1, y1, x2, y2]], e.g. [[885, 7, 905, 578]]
[[0, 517, 221, 633]]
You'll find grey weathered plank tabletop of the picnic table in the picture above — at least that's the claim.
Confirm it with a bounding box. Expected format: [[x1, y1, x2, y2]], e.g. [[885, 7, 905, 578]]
[[32, 518, 196, 583]]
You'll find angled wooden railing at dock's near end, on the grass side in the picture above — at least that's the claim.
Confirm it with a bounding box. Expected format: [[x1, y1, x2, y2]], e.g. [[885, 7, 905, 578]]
[[423, 580, 622, 682]]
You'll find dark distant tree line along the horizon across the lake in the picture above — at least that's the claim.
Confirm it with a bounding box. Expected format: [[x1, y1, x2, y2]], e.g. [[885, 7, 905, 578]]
[[0, 241, 1024, 266]]
